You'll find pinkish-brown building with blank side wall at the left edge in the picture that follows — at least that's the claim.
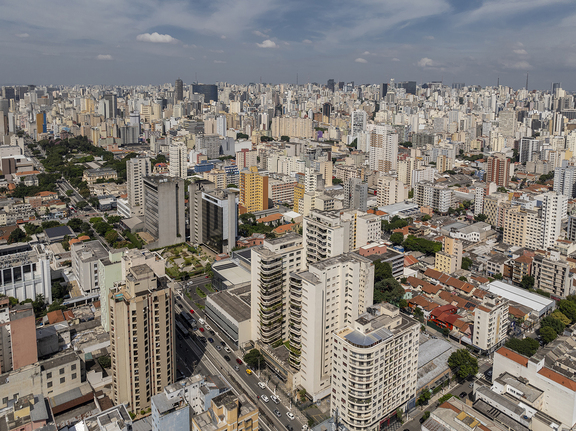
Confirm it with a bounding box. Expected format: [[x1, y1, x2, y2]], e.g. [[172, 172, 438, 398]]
[[0, 296, 38, 374]]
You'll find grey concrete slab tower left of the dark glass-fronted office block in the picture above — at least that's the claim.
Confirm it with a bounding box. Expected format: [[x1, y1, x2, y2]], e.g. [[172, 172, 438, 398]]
[[144, 175, 186, 248]]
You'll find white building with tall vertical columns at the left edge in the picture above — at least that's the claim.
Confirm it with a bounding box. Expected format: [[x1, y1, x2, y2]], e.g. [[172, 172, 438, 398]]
[[0, 243, 52, 303]]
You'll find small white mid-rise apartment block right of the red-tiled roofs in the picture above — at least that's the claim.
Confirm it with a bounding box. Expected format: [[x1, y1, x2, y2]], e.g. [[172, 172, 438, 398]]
[[472, 294, 508, 353]]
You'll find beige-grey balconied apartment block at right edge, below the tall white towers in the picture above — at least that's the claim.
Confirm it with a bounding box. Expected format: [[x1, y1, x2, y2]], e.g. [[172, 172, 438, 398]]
[[531, 251, 575, 300]]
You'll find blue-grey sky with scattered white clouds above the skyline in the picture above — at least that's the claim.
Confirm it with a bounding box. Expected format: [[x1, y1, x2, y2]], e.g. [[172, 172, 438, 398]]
[[0, 0, 576, 91]]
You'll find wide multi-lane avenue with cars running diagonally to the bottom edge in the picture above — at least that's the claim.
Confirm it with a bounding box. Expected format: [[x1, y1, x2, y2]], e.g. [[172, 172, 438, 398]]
[[175, 284, 302, 431]]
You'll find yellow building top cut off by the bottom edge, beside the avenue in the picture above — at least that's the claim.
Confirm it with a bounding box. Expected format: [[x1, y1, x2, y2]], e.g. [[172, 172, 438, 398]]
[[192, 391, 258, 431]]
